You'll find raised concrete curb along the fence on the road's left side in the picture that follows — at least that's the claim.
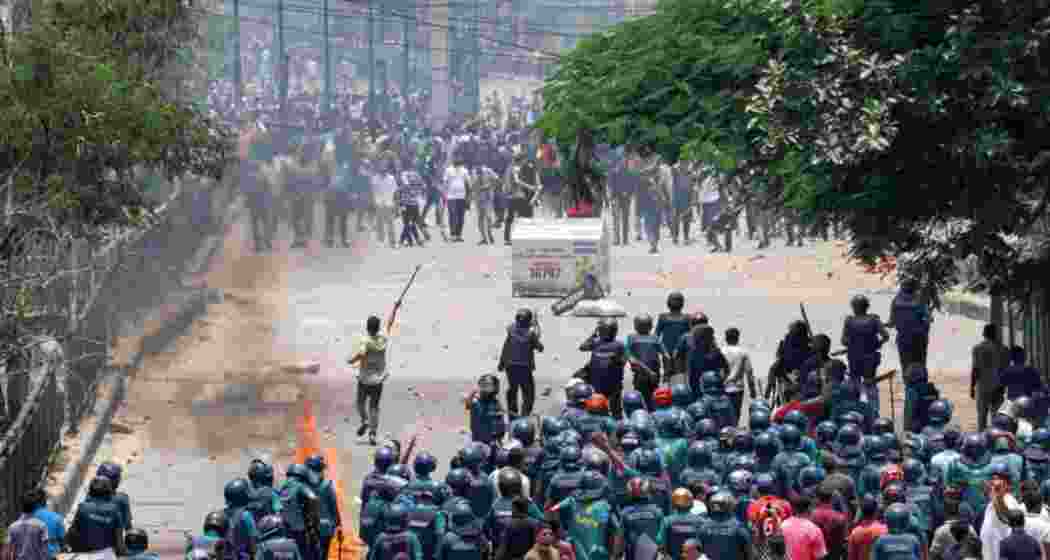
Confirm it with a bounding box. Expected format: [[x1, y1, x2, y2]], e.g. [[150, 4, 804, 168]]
[[51, 196, 243, 516]]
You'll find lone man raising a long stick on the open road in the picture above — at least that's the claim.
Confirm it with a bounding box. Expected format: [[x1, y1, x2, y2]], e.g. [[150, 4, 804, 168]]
[[347, 266, 420, 445]]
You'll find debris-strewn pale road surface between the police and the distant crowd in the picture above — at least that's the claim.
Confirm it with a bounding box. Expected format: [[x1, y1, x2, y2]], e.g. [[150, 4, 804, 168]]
[[71, 206, 980, 556]]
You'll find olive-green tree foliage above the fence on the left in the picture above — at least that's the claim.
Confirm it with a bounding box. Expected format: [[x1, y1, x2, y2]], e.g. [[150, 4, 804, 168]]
[[0, 0, 232, 234]]
